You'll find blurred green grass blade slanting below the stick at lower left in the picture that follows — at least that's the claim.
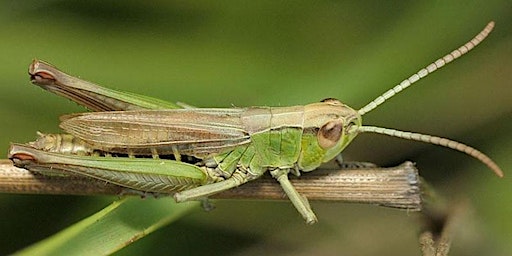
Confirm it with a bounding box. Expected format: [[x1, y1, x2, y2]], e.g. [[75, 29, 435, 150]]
[[16, 197, 197, 255]]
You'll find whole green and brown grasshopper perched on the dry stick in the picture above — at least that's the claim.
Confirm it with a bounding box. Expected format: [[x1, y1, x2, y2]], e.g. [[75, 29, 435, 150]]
[[9, 22, 503, 224]]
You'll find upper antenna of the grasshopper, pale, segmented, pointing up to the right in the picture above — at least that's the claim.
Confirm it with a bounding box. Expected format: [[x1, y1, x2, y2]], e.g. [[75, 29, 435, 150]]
[[358, 21, 494, 116]]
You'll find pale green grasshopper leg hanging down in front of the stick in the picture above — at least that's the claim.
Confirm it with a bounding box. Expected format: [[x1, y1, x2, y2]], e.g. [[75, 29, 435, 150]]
[[270, 169, 318, 224]]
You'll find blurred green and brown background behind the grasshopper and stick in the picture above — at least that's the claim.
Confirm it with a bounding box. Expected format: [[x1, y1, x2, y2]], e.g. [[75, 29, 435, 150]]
[[0, 0, 512, 255]]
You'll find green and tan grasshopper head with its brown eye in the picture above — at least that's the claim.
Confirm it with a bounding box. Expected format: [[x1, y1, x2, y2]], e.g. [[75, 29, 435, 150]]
[[299, 98, 362, 171]]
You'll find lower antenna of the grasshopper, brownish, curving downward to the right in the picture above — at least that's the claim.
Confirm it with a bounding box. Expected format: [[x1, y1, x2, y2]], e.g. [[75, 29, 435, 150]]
[[358, 126, 503, 177]]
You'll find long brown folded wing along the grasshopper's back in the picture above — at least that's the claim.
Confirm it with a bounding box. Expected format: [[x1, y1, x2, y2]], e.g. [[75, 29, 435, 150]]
[[60, 108, 250, 155]]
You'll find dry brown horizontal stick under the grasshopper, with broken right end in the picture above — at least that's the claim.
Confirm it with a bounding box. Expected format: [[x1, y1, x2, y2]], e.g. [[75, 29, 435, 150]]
[[0, 160, 421, 211]]
